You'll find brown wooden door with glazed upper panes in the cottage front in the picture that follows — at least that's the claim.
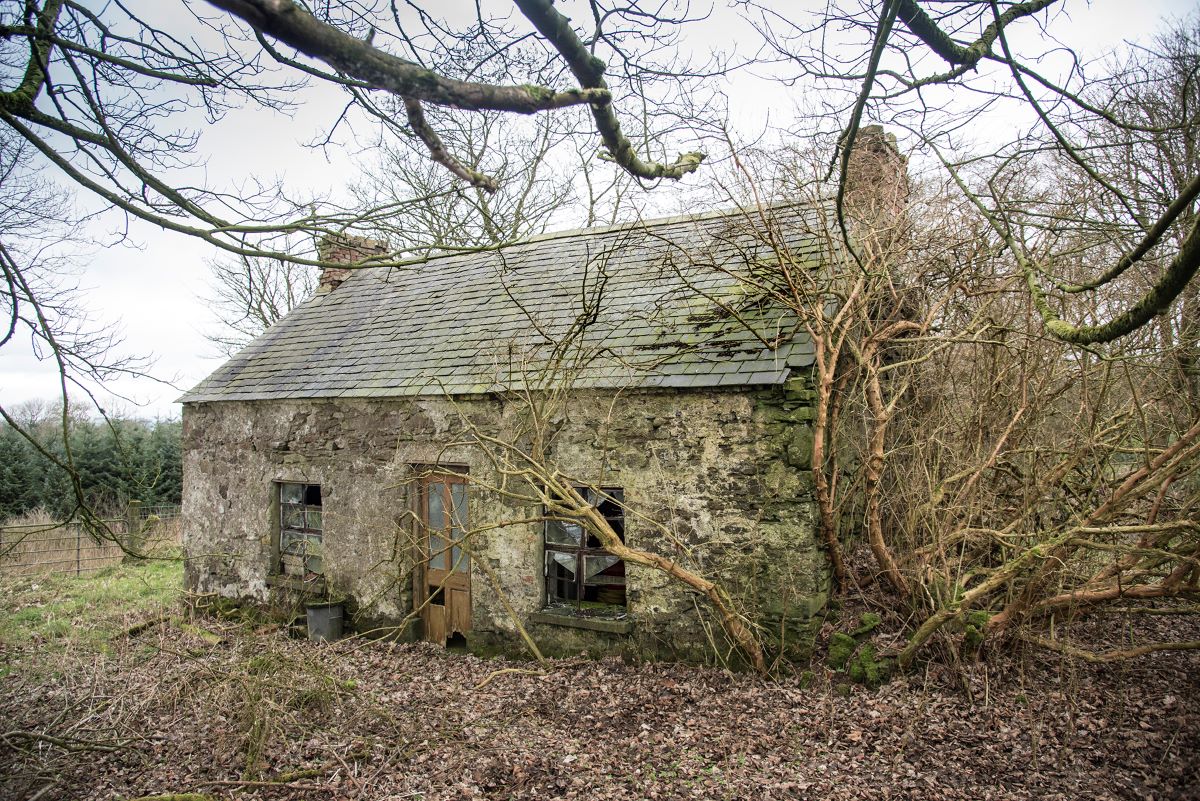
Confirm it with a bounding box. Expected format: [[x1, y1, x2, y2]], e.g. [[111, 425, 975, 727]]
[[419, 472, 470, 645]]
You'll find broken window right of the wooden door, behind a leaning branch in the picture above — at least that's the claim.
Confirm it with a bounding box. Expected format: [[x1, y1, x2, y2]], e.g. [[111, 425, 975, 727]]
[[545, 487, 625, 616]]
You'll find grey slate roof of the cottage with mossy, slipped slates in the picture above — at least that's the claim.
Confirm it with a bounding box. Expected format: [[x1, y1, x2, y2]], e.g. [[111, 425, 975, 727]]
[[180, 205, 823, 403]]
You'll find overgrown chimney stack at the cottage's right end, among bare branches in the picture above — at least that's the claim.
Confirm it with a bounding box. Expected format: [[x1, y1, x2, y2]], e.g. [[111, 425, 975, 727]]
[[844, 125, 911, 234]]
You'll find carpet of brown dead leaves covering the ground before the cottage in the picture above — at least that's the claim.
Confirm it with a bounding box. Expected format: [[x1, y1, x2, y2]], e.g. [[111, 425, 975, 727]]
[[0, 625, 1200, 801]]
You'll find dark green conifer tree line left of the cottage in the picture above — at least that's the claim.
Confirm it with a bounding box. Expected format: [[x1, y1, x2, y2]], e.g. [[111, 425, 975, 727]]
[[0, 404, 181, 523]]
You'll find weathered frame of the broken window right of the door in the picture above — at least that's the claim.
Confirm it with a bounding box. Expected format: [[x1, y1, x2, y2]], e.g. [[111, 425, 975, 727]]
[[541, 487, 629, 618]]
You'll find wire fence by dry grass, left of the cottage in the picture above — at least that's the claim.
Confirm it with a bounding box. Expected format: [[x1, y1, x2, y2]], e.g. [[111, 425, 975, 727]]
[[0, 502, 180, 576]]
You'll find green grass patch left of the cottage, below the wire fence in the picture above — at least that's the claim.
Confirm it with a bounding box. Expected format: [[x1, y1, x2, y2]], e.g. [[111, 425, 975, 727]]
[[0, 560, 184, 651]]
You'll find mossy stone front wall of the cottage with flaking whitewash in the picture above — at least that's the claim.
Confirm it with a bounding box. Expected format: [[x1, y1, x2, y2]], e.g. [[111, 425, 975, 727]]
[[184, 380, 828, 661]]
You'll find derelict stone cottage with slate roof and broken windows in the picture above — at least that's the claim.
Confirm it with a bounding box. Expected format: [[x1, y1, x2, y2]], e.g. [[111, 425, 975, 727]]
[[182, 205, 829, 661]]
